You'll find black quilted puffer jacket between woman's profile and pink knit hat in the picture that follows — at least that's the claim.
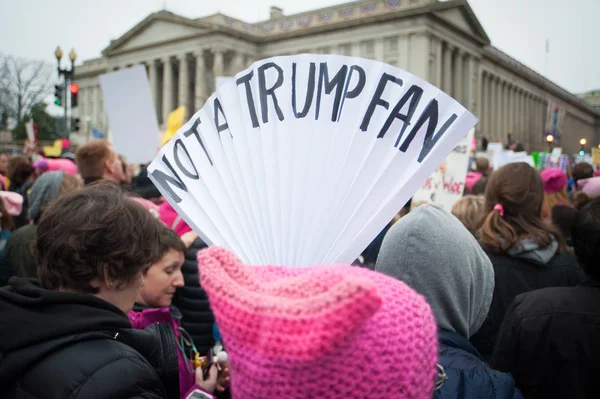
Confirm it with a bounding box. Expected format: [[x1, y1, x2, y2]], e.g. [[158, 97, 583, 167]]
[[173, 239, 215, 353]]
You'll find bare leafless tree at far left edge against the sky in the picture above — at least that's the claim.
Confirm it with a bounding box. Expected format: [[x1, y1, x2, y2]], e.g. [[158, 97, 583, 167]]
[[0, 55, 55, 125]]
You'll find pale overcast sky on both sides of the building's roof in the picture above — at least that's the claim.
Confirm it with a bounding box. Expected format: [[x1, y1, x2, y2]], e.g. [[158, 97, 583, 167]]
[[0, 0, 600, 93]]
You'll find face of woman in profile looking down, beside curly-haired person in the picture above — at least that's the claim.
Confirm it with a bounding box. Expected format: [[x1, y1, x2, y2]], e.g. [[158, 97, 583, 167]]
[[138, 249, 185, 308]]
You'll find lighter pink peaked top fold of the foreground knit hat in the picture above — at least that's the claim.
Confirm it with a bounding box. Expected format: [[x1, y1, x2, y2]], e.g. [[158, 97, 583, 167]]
[[198, 247, 381, 360]]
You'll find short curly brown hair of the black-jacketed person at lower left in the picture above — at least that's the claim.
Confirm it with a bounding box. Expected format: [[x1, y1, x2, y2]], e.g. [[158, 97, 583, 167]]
[[35, 182, 162, 293]]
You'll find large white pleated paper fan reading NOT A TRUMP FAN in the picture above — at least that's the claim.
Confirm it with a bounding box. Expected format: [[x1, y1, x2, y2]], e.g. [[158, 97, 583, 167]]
[[148, 54, 477, 266]]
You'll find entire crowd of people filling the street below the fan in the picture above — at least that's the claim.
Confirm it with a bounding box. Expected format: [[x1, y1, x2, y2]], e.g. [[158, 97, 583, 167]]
[[0, 140, 600, 399]]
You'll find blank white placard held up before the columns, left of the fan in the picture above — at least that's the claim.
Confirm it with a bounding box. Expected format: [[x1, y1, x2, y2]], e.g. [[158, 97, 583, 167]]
[[100, 65, 160, 164]]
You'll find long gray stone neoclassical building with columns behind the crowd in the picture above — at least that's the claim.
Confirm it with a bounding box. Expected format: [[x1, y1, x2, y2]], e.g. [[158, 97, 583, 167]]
[[75, 0, 600, 153]]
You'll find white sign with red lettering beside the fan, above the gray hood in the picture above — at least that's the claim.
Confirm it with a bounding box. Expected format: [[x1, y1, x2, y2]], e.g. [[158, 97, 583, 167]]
[[411, 129, 475, 212]]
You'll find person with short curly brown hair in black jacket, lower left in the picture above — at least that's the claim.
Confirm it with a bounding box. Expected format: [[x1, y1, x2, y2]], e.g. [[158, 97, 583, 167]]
[[0, 183, 179, 399]]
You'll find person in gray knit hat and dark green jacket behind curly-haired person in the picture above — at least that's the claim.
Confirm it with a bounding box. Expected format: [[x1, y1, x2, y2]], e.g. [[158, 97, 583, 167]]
[[6, 171, 82, 278]]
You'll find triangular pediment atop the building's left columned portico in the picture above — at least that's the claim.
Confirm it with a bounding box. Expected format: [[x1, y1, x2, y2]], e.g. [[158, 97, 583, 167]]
[[103, 11, 211, 56]]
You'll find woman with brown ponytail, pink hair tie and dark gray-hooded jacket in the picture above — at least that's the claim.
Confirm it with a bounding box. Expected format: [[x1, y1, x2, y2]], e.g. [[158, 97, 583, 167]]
[[471, 162, 583, 360]]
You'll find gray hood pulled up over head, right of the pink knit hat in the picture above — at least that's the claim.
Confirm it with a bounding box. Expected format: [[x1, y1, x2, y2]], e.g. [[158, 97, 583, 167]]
[[375, 205, 494, 338]]
